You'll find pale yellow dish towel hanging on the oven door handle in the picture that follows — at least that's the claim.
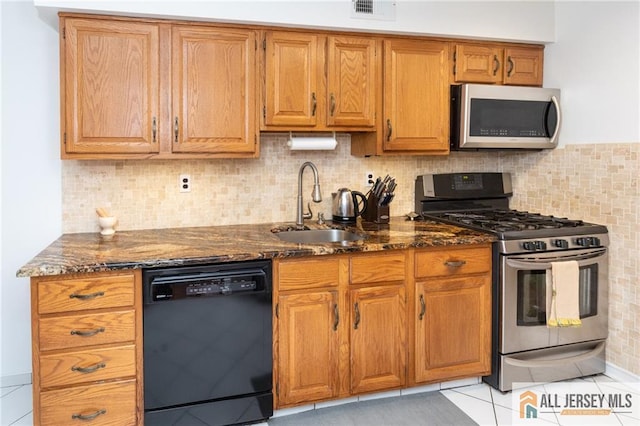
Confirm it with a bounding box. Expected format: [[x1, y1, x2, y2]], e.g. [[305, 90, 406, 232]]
[[546, 260, 582, 327]]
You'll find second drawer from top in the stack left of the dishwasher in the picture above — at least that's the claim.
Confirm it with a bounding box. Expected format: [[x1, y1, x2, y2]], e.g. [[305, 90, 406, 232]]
[[38, 310, 135, 351]]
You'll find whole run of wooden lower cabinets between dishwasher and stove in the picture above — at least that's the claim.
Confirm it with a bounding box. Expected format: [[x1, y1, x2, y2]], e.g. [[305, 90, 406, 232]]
[[273, 244, 491, 409]]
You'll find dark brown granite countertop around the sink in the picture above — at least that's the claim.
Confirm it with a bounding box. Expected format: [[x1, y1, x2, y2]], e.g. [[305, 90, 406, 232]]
[[17, 217, 495, 277]]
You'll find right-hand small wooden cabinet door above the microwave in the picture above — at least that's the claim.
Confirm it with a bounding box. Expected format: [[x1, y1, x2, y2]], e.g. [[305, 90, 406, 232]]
[[504, 47, 544, 86]]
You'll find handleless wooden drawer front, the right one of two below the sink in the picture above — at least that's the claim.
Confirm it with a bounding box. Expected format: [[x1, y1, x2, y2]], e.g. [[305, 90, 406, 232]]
[[351, 251, 405, 284]]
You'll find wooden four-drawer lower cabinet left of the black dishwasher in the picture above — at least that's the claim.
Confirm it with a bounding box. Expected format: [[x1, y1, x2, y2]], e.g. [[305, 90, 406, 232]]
[[31, 270, 144, 426]]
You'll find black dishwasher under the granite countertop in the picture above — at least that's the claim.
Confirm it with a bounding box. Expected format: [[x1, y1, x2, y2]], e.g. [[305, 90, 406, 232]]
[[142, 261, 273, 426]]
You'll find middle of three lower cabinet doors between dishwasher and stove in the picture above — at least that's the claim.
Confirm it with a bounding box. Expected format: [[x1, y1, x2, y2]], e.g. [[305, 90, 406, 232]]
[[350, 285, 406, 394]]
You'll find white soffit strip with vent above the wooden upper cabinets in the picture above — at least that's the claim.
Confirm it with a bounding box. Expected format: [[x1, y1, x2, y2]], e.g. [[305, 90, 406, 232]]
[[34, 0, 554, 42]]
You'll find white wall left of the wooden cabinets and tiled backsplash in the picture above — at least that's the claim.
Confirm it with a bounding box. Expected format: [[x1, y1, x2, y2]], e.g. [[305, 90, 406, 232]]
[[0, 1, 62, 384]]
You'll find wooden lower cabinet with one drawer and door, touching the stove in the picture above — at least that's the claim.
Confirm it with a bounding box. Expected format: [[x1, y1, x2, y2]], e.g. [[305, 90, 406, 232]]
[[414, 248, 491, 383]]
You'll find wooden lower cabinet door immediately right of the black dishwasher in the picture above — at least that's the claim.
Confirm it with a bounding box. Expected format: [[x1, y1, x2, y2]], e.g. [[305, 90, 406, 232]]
[[276, 291, 340, 406]]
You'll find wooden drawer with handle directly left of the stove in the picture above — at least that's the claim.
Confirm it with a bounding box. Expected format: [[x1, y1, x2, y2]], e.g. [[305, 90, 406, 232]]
[[416, 247, 491, 277]]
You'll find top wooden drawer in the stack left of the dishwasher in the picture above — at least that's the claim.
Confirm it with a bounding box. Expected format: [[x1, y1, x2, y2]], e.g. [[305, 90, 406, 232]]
[[38, 273, 134, 314]]
